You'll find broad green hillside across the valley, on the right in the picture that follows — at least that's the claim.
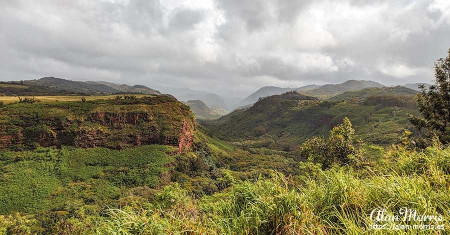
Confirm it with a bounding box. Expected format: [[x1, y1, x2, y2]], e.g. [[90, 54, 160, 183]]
[[205, 92, 417, 149]]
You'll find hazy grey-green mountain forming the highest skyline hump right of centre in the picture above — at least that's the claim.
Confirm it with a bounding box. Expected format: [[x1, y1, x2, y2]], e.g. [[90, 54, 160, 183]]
[[301, 80, 385, 98]]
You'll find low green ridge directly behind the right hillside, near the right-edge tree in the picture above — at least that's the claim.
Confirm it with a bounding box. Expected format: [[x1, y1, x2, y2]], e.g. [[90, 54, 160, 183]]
[[329, 86, 418, 101]]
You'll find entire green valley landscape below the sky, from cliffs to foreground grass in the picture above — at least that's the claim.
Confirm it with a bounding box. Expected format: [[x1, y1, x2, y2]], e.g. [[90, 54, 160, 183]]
[[0, 69, 450, 234]]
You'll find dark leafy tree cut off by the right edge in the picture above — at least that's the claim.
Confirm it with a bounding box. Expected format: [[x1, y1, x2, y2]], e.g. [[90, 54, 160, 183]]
[[410, 49, 450, 144]]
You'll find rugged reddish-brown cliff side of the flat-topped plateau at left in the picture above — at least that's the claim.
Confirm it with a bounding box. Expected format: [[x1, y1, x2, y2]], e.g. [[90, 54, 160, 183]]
[[0, 96, 196, 151]]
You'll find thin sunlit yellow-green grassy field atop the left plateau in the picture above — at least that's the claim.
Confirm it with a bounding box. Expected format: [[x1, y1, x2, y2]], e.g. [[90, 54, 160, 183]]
[[0, 94, 152, 104]]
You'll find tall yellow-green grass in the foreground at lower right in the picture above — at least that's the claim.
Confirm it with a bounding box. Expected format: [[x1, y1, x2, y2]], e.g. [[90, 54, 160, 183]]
[[94, 147, 450, 234]]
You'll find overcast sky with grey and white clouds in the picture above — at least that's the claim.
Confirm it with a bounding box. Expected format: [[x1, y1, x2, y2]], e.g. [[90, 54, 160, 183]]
[[0, 0, 450, 96]]
